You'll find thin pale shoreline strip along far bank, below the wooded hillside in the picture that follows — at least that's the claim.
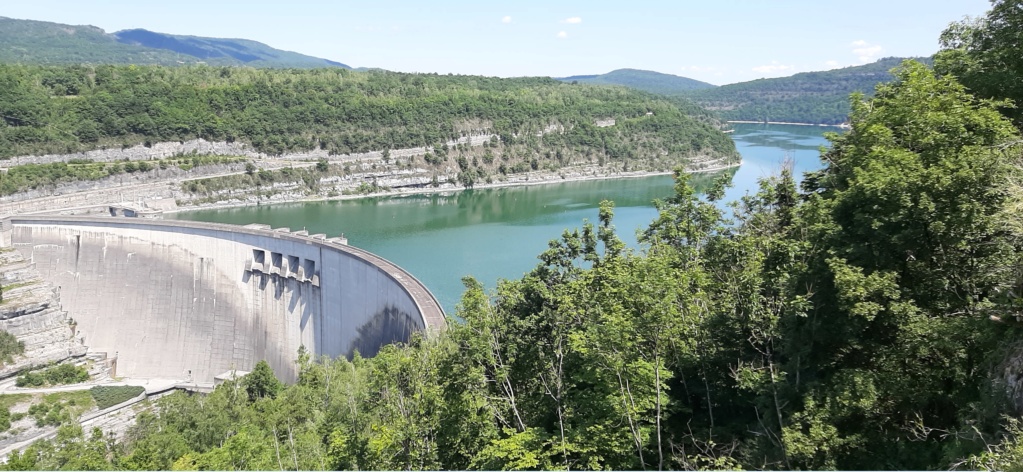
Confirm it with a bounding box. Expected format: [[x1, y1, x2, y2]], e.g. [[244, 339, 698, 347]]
[[162, 161, 743, 215]]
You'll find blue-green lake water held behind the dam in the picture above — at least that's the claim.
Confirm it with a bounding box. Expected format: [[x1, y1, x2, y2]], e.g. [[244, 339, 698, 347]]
[[167, 124, 839, 313]]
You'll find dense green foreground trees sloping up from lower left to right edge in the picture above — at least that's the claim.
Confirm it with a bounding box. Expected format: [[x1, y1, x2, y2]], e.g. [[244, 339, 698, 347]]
[[12, 57, 1023, 470]]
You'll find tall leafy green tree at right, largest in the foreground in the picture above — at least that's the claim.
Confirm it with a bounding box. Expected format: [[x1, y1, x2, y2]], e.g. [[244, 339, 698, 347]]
[[781, 61, 1019, 468]]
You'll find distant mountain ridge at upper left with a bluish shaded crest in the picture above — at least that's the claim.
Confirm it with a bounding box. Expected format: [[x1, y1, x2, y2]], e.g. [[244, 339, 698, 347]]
[[0, 16, 351, 69]]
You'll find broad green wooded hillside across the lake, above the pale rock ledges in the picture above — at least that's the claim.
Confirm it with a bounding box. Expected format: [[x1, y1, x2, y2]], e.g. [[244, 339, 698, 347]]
[[0, 66, 737, 169]]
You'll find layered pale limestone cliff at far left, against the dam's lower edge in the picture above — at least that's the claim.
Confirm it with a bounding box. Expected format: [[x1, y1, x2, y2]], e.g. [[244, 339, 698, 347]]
[[0, 248, 86, 378]]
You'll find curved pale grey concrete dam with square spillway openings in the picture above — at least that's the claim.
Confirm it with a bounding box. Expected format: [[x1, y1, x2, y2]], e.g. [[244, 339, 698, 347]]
[[3, 216, 445, 383]]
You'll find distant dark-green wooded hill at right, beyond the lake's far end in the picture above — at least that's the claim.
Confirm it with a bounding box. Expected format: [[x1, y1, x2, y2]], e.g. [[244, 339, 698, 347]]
[[685, 57, 930, 125]]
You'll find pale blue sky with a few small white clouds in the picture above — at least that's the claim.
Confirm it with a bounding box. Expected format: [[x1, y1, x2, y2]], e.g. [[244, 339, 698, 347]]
[[0, 0, 990, 85]]
